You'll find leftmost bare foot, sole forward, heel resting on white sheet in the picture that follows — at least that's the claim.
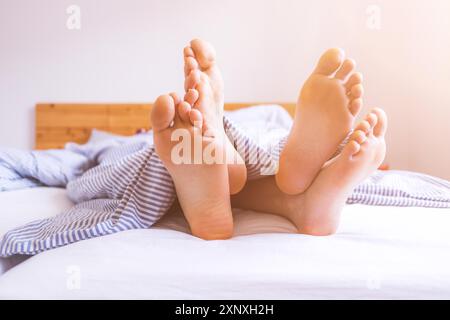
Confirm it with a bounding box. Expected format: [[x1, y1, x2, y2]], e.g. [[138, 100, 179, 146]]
[[152, 89, 233, 240]]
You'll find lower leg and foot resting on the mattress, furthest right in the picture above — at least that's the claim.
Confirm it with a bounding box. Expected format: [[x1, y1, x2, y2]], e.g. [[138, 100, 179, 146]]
[[232, 109, 387, 236]]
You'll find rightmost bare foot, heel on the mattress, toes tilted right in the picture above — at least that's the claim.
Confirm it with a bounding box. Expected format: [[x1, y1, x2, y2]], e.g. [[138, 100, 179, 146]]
[[289, 109, 387, 235]]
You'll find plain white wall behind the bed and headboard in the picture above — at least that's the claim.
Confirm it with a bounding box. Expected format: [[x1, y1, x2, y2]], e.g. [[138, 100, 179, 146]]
[[0, 0, 450, 179]]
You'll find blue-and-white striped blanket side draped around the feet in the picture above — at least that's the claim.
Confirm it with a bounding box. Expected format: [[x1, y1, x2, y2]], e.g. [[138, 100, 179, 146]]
[[0, 111, 450, 257]]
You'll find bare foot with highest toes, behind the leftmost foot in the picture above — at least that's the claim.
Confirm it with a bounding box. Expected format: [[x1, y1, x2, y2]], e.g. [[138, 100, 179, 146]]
[[184, 39, 247, 194]]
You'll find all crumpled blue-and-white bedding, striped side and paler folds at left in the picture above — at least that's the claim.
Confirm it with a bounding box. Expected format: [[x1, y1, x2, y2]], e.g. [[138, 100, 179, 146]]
[[0, 106, 450, 256]]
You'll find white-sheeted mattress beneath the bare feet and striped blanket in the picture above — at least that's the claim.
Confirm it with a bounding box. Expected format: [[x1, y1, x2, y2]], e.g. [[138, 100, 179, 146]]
[[0, 188, 450, 299]]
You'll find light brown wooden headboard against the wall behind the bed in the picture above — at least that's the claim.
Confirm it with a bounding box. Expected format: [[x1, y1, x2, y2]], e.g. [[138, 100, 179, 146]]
[[35, 103, 295, 150]]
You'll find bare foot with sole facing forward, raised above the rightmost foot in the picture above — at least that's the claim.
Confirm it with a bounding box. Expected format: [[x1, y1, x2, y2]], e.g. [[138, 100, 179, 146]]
[[276, 49, 363, 195]]
